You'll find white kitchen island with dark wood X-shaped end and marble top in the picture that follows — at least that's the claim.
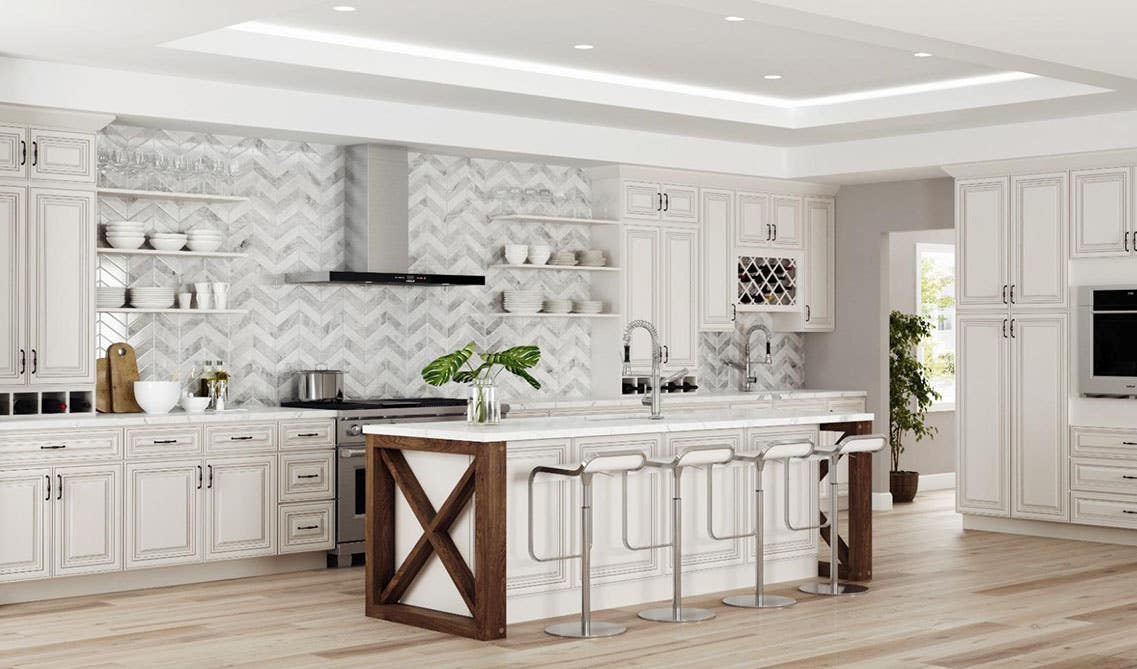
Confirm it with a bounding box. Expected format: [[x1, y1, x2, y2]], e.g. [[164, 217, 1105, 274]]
[[364, 410, 873, 639]]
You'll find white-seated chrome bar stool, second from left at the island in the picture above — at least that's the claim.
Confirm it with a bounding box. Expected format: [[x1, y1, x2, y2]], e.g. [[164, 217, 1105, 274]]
[[622, 446, 735, 622]]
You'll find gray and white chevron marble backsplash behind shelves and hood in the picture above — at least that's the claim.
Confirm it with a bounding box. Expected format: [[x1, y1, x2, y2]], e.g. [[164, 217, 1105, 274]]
[[97, 124, 804, 405]]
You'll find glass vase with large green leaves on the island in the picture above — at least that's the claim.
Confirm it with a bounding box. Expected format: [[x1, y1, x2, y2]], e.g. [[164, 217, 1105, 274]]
[[422, 341, 541, 426]]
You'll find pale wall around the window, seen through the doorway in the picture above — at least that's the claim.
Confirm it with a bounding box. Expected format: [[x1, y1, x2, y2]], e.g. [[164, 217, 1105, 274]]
[[886, 230, 955, 474]]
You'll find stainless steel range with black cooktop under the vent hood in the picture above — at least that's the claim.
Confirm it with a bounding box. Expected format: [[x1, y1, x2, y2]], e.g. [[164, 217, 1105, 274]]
[[281, 397, 466, 567]]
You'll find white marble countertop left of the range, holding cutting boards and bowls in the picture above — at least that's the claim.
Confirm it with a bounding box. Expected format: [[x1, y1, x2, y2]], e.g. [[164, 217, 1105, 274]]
[[0, 406, 335, 432]]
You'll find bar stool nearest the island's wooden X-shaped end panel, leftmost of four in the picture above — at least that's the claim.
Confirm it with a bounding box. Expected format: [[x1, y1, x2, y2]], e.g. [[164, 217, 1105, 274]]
[[529, 451, 647, 638]]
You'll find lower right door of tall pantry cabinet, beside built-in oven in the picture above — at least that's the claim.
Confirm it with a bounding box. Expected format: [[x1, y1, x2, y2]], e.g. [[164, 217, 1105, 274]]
[[1011, 314, 1069, 520]]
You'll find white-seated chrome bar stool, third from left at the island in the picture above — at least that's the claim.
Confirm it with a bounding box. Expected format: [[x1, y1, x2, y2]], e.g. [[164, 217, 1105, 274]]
[[707, 439, 813, 609]]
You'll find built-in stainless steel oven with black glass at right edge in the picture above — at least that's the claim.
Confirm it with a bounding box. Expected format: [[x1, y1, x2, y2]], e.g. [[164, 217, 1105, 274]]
[[1078, 286, 1137, 397]]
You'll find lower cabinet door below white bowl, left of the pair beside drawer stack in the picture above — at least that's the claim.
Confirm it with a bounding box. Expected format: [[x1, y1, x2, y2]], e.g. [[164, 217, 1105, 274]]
[[123, 460, 205, 569]]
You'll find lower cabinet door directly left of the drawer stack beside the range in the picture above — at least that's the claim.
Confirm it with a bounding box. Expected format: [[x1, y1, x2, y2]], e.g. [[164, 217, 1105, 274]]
[[206, 455, 276, 561]]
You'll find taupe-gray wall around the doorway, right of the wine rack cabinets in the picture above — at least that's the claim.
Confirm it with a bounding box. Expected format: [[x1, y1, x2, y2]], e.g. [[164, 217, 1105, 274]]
[[805, 177, 955, 492]]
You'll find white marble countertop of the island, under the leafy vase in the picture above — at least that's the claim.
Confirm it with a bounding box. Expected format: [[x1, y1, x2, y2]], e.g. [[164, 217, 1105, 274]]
[[363, 408, 873, 443]]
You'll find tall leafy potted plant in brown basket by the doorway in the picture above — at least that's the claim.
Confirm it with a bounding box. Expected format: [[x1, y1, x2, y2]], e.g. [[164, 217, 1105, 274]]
[[888, 312, 940, 502]]
